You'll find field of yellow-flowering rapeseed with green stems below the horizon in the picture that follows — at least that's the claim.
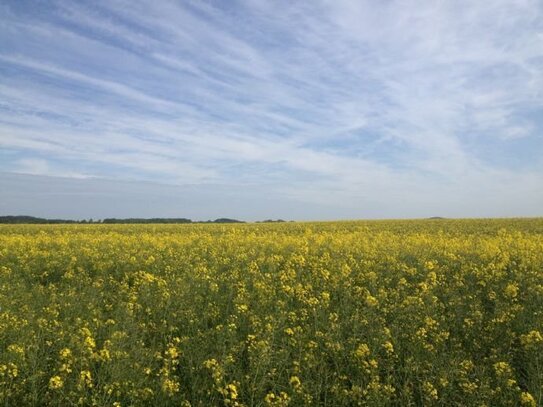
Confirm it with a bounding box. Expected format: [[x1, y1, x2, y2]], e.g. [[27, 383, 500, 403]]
[[0, 219, 543, 406]]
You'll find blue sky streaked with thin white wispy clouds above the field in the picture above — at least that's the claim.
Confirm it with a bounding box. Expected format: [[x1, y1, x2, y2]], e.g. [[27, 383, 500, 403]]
[[0, 0, 543, 220]]
